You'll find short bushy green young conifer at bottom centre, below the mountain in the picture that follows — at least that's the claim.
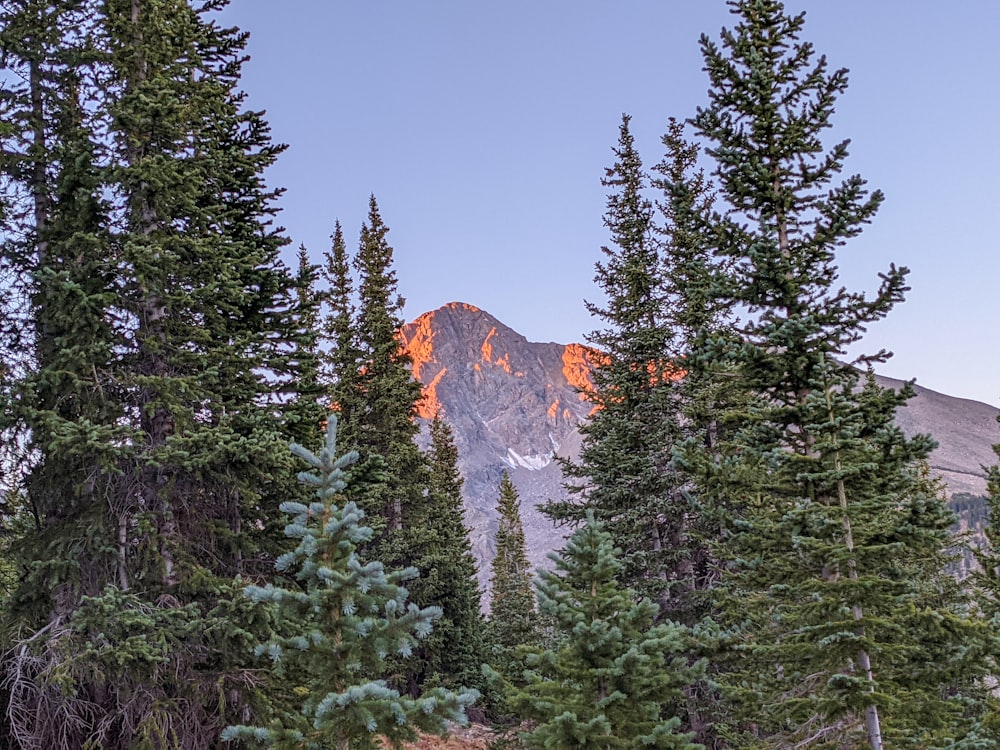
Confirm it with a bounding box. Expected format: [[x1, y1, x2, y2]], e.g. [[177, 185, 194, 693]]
[[510, 515, 702, 750]]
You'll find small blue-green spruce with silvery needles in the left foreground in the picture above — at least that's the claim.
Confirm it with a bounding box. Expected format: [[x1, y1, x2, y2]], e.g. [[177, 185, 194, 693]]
[[222, 416, 475, 750]]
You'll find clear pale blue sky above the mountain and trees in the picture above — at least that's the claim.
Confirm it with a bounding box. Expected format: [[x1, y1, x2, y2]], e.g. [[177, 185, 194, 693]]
[[223, 0, 1000, 405]]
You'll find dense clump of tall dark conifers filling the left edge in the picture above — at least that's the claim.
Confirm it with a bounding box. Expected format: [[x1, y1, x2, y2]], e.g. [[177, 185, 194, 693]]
[[5, 0, 296, 750]]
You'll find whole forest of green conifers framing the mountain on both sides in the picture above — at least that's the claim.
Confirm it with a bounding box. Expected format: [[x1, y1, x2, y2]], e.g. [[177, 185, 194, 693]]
[[0, 0, 1000, 750]]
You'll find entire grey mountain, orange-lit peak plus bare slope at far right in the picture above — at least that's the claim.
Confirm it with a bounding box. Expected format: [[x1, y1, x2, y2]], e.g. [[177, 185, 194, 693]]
[[400, 302, 1000, 584]]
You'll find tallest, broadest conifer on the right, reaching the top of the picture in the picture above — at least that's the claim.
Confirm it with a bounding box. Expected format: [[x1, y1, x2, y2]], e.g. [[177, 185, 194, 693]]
[[684, 0, 981, 748]]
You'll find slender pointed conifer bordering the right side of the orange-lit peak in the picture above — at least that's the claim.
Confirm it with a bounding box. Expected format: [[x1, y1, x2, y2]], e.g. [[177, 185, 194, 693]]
[[546, 115, 686, 612]]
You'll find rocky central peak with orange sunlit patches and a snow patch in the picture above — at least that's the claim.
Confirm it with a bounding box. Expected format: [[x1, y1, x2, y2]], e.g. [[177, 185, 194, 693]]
[[400, 302, 597, 579]]
